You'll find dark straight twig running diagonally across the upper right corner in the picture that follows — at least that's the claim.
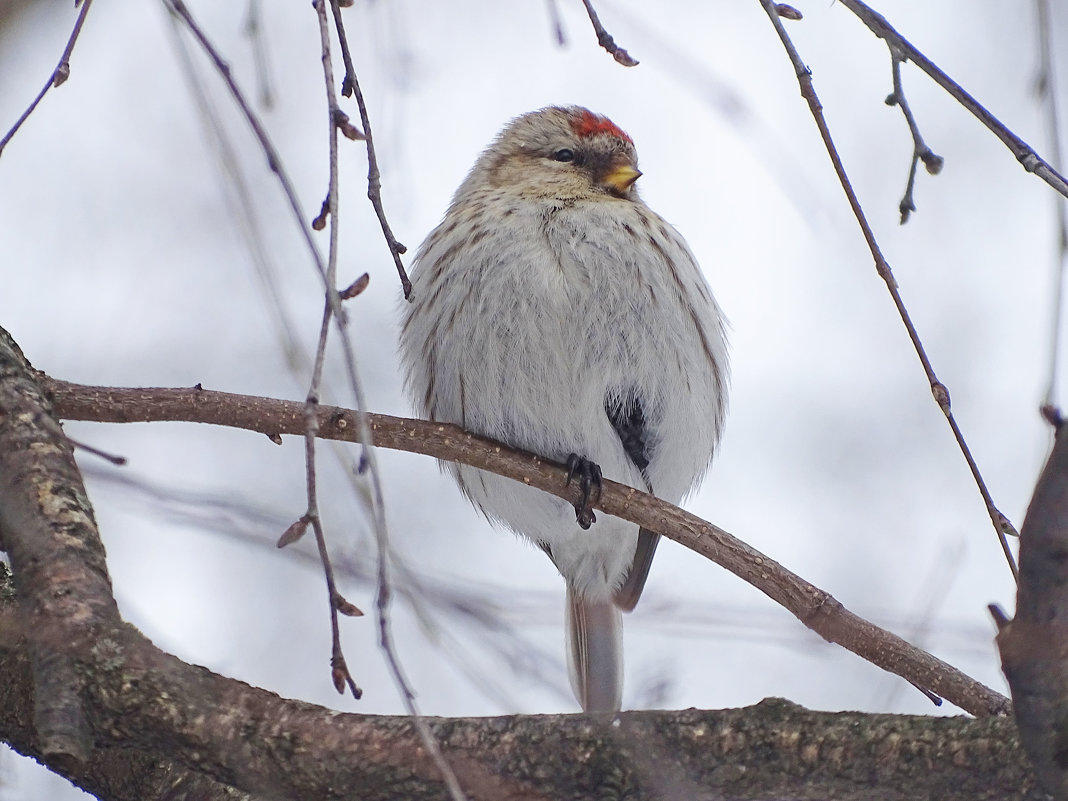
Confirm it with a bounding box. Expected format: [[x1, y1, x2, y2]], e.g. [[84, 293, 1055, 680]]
[[838, 0, 1068, 198]]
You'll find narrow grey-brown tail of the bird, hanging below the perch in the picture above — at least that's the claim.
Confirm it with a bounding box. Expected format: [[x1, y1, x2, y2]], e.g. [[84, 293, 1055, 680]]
[[567, 587, 623, 712]]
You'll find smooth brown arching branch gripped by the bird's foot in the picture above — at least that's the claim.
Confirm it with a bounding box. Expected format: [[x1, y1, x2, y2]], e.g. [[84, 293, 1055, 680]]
[[42, 376, 1009, 716]]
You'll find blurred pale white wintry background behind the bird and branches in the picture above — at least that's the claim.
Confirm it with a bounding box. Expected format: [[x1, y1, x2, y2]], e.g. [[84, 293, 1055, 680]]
[[0, 0, 1055, 801]]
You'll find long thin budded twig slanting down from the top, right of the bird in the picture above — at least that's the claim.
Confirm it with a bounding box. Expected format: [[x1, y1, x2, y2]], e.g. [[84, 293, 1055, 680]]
[[758, 0, 1019, 579]]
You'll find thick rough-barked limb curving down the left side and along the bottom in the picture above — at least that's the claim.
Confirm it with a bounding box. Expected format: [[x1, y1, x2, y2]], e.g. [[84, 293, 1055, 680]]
[[0, 322, 1039, 801]]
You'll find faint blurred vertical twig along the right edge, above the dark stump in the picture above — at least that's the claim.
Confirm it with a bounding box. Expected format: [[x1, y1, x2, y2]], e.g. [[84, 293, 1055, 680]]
[[1036, 0, 1068, 406]]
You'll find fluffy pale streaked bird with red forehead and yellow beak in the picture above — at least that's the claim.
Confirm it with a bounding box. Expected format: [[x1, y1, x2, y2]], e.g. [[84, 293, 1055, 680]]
[[401, 106, 728, 711]]
